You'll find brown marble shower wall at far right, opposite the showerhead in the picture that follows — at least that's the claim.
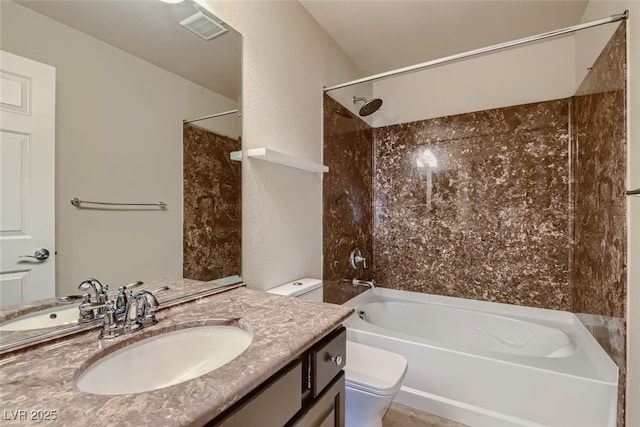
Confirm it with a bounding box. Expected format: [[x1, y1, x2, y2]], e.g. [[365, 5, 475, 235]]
[[571, 22, 627, 425]]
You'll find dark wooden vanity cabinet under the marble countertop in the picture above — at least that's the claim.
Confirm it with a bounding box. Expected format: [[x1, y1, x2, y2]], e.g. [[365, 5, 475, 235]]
[[207, 327, 347, 427]]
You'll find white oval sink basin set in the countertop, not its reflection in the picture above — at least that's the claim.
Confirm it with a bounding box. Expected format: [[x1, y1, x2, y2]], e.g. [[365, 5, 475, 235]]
[[76, 326, 253, 395]]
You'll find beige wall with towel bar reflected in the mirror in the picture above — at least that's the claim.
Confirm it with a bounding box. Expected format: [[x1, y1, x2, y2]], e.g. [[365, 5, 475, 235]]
[[1, 1, 238, 294]]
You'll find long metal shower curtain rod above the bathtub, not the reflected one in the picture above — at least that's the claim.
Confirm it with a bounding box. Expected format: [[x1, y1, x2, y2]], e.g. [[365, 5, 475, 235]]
[[323, 10, 629, 92]]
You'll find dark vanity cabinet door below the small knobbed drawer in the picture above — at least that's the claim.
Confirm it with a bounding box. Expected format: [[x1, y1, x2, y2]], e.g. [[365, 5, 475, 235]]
[[287, 371, 345, 427]]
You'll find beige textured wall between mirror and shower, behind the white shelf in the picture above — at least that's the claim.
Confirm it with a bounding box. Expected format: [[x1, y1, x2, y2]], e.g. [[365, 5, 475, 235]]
[[203, 0, 360, 289]]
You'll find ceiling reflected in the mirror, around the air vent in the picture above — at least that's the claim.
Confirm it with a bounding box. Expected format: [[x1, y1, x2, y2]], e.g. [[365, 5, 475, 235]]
[[15, 0, 242, 100]]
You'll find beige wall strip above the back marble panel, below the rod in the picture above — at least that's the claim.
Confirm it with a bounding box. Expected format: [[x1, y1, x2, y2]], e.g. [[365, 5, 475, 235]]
[[373, 36, 575, 127]]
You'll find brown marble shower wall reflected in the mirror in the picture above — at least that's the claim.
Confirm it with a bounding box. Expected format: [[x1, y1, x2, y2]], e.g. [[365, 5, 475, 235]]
[[183, 125, 241, 281]]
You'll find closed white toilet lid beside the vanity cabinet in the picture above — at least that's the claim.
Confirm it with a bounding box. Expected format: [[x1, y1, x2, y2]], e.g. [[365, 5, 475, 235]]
[[344, 340, 407, 394]]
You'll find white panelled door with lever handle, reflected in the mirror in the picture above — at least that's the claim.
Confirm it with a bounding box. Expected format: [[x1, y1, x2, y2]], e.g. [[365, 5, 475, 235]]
[[0, 51, 56, 307]]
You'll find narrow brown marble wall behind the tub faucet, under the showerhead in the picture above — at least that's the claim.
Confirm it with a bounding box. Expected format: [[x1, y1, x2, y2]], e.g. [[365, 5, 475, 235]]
[[322, 95, 373, 304]]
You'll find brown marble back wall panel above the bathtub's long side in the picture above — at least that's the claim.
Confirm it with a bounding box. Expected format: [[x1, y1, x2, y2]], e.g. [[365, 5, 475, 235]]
[[373, 99, 571, 310]]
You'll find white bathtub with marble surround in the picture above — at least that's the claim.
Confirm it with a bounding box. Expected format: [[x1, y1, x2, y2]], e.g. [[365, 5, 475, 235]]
[[345, 288, 618, 427]]
